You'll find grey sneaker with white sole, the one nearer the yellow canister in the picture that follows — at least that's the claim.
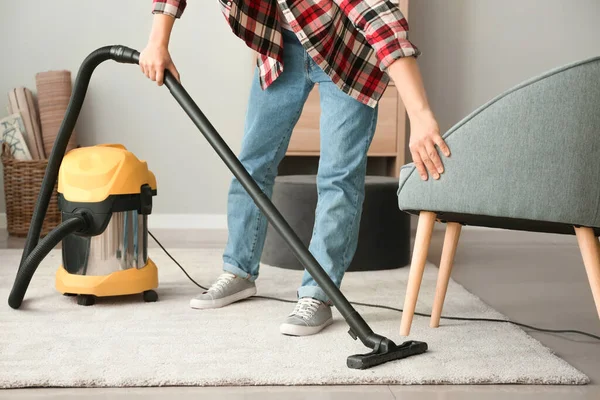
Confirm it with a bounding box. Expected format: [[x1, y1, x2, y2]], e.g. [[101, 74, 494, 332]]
[[190, 272, 256, 309]]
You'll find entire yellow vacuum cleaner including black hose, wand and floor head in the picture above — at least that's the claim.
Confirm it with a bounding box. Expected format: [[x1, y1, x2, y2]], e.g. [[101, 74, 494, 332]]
[[8, 46, 427, 369]]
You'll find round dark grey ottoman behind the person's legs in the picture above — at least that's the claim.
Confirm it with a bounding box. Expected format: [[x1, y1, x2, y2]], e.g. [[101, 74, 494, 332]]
[[261, 175, 411, 271]]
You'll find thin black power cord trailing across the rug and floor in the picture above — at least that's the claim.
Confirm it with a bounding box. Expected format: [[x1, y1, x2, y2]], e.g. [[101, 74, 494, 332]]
[[148, 231, 600, 340]]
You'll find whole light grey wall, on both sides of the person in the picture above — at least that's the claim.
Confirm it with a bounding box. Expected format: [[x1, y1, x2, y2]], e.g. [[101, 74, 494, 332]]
[[0, 0, 600, 225]]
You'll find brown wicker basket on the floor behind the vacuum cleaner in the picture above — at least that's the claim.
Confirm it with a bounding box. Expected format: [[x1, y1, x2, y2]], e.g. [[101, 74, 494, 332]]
[[2, 143, 61, 237]]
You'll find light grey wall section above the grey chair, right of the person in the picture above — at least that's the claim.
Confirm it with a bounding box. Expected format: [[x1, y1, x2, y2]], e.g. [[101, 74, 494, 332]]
[[409, 0, 600, 138]]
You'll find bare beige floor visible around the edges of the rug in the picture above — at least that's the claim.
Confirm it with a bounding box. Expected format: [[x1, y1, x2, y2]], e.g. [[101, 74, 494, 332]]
[[0, 229, 600, 400]]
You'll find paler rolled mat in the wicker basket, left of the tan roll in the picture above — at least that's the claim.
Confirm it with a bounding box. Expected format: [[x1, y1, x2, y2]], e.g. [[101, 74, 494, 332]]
[[8, 87, 46, 160]]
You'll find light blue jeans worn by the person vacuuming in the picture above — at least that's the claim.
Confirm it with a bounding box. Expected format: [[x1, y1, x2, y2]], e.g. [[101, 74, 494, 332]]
[[223, 31, 377, 302]]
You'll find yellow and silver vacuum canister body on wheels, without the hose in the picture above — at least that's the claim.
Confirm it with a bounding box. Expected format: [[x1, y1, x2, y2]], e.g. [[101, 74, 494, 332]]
[[56, 144, 158, 305]]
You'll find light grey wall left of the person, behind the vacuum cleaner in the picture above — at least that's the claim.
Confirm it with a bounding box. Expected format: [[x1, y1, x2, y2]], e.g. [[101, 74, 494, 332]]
[[0, 0, 252, 223]]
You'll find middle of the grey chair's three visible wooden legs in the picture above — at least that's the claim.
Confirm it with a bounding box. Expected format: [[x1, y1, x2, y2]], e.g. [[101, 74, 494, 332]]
[[429, 222, 462, 328]]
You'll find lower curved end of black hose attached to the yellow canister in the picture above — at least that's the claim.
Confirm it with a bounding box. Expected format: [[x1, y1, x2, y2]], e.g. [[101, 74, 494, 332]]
[[8, 217, 87, 309]]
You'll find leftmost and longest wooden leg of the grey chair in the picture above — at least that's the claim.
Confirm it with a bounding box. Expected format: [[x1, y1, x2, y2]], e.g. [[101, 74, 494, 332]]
[[400, 211, 436, 336]]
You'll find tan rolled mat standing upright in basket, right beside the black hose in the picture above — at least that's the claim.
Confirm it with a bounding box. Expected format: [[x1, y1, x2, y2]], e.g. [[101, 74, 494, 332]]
[[35, 70, 77, 156]]
